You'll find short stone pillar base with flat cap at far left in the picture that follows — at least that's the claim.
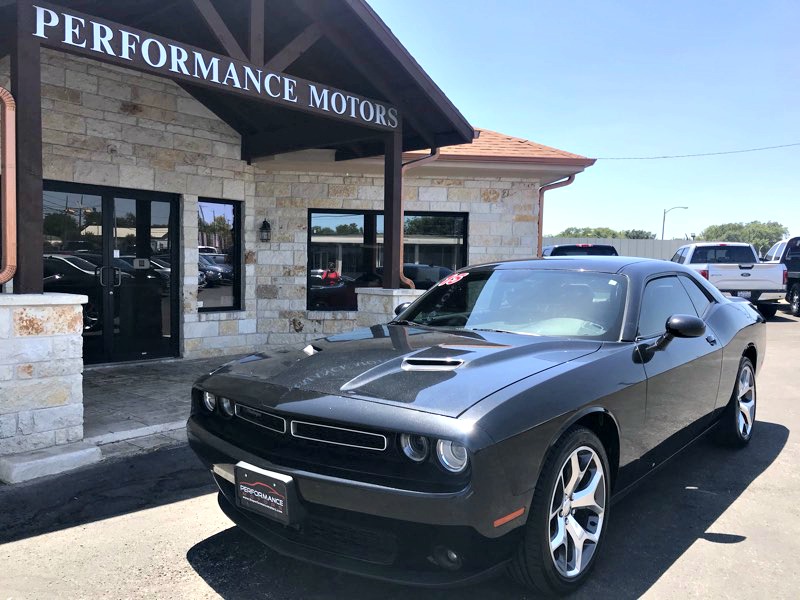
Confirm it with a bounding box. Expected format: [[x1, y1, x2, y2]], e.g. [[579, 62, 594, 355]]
[[0, 294, 100, 483]]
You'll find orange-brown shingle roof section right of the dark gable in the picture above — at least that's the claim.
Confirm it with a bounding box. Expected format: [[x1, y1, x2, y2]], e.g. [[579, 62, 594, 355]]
[[413, 128, 595, 167]]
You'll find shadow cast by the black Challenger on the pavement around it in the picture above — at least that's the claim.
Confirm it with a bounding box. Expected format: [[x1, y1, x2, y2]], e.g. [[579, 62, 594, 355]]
[[186, 422, 789, 600]]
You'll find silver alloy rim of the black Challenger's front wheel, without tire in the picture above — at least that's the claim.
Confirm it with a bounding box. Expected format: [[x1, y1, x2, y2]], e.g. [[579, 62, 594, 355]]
[[549, 446, 606, 578]]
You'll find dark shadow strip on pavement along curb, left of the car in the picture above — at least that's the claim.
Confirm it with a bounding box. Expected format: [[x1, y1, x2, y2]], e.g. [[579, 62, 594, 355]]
[[0, 444, 216, 544]]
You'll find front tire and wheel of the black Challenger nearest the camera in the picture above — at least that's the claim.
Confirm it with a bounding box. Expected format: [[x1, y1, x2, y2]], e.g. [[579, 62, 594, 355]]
[[509, 427, 611, 596]]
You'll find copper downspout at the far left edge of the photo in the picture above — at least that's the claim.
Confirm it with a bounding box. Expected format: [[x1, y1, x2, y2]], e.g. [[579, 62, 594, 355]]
[[0, 87, 17, 285]]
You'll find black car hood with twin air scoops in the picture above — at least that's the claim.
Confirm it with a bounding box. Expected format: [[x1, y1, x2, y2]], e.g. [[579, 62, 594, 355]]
[[211, 325, 602, 417]]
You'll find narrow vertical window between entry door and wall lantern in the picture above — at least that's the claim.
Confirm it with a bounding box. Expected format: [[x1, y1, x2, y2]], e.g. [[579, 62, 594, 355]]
[[197, 198, 242, 312]]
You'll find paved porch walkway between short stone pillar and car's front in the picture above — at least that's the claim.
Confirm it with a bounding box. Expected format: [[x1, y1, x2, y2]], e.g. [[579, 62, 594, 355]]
[[83, 355, 241, 454]]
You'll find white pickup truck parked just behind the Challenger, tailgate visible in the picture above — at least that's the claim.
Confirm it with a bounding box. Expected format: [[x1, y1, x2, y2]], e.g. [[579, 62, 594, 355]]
[[671, 242, 787, 319]]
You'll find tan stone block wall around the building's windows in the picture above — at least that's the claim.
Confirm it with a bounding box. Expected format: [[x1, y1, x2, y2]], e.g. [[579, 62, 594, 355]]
[[0, 50, 539, 358]]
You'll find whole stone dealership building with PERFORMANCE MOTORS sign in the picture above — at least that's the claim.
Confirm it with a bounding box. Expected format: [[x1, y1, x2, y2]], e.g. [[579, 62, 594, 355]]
[[0, 0, 593, 480]]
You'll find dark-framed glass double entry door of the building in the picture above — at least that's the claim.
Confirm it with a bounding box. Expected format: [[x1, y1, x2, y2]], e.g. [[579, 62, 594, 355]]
[[44, 183, 179, 364]]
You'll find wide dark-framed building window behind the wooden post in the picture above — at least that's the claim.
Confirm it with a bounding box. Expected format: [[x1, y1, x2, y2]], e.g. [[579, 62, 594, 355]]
[[307, 210, 467, 310]]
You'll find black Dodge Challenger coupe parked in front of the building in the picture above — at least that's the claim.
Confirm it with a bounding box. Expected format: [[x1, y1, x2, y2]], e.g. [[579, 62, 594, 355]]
[[187, 257, 765, 594]]
